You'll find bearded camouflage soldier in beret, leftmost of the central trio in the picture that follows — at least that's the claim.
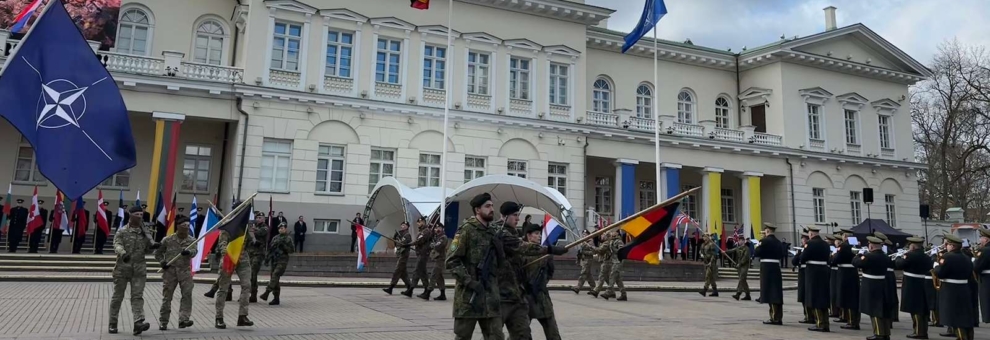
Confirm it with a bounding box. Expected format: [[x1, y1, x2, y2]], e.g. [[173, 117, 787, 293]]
[[448, 193, 505, 340]]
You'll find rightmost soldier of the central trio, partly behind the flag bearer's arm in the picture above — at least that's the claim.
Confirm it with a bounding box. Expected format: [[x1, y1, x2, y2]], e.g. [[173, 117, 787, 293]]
[[523, 224, 560, 340]]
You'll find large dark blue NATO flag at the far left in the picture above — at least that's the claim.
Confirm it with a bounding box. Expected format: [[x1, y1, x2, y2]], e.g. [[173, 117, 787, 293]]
[[0, 1, 137, 197]]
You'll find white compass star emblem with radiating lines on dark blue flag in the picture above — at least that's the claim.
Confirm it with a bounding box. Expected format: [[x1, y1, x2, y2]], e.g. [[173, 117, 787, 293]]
[[21, 57, 113, 160]]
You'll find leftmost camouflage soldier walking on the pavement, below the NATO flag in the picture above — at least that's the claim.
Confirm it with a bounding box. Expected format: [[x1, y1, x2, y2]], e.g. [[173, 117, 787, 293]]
[[109, 207, 158, 335]]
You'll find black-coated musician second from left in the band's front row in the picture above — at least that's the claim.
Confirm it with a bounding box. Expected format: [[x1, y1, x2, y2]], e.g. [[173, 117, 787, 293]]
[[800, 226, 832, 332]]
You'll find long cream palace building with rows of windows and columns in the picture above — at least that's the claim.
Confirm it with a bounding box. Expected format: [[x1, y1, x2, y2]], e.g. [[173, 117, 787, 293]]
[[0, 0, 931, 251]]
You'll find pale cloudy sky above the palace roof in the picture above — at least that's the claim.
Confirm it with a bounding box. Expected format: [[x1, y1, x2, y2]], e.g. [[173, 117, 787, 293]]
[[585, 0, 990, 64]]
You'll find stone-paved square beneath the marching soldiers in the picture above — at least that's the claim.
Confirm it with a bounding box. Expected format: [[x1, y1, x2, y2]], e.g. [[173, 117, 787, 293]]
[[0, 282, 990, 340]]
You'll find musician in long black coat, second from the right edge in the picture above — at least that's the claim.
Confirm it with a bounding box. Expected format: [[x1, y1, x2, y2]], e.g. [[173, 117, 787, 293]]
[[932, 234, 976, 340]]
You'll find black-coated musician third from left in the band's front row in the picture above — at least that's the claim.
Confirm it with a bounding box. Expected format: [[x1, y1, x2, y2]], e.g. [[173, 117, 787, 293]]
[[834, 229, 860, 330]]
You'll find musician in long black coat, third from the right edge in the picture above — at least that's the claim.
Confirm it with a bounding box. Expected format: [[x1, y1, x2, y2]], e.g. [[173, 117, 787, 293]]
[[894, 237, 932, 339]]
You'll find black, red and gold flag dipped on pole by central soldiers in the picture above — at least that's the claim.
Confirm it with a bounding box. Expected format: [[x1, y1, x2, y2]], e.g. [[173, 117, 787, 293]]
[[619, 202, 680, 264]]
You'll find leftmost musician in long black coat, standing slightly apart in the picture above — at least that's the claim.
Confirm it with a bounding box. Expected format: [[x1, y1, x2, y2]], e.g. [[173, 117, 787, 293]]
[[756, 223, 785, 325]]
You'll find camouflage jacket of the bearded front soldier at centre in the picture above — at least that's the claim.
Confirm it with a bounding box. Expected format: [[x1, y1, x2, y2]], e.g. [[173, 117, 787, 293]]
[[446, 217, 504, 319]]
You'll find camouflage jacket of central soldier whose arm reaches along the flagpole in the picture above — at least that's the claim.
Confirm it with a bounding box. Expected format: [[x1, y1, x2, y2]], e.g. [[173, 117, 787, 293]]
[[492, 220, 547, 303]]
